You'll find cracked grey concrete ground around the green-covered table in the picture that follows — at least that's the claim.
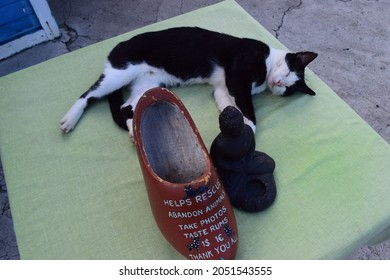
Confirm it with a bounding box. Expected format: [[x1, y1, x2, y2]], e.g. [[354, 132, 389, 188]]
[[0, 0, 390, 259]]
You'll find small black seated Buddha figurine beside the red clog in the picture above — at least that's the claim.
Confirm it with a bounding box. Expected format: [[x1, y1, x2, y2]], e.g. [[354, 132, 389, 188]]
[[210, 106, 276, 212]]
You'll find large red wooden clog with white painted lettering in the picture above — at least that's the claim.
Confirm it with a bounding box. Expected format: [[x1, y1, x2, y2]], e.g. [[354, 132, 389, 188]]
[[133, 88, 238, 260]]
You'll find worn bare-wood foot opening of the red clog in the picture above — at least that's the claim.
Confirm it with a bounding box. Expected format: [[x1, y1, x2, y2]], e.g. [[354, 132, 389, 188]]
[[141, 101, 207, 183]]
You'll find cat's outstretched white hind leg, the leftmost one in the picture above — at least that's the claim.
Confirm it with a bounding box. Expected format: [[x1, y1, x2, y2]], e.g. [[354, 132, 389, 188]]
[[60, 62, 133, 133]]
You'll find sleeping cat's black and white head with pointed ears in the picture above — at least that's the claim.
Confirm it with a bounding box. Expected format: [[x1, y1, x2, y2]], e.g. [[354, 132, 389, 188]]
[[267, 52, 317, 96]]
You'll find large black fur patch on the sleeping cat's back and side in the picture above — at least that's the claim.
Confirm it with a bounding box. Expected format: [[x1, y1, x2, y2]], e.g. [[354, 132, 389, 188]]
[[108, 27, 269, 77]]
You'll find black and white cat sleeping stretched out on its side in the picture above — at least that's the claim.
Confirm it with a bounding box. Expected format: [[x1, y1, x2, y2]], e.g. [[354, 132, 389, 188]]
[[60, 27, 317, 137]]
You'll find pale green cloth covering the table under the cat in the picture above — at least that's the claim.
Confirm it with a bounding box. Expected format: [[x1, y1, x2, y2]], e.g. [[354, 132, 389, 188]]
[[0, 1, 390, 259]]
